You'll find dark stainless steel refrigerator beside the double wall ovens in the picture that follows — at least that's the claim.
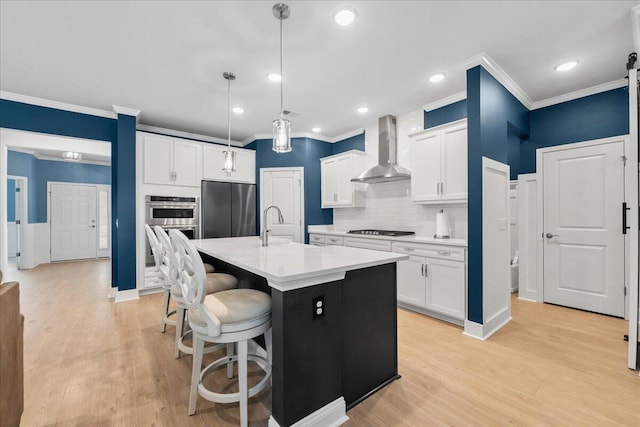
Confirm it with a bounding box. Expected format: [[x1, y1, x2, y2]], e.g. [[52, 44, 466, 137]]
[[200, 181, 257, 239]]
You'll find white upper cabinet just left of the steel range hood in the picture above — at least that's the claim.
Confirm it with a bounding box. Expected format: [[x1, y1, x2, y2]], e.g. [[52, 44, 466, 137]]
[[320, 150, 369, 208]]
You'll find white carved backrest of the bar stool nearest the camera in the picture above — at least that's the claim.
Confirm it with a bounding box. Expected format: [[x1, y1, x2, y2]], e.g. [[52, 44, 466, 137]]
[[169, 230, 221, 336]]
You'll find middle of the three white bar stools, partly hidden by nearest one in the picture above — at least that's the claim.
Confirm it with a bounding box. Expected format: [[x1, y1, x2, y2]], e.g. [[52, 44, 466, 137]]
[[154, 226, 238, 362]]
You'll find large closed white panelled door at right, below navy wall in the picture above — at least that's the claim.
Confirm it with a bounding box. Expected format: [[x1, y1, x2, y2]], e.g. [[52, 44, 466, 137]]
[[543, 140, 624, 317]]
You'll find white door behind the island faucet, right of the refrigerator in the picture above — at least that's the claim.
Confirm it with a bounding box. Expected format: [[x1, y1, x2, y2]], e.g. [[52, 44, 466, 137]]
[[260, 168, 304, 243]]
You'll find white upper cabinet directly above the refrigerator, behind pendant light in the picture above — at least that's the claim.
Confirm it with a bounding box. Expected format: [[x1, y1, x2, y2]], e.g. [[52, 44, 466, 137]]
[[202, 144, 256, 184]]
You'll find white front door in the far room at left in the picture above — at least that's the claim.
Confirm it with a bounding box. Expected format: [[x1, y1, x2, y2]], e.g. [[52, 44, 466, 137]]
[[50, 184, 97, 261]]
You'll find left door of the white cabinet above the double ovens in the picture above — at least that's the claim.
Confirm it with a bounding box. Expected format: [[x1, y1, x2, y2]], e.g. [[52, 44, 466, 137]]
[[143, 135, 173, 184]]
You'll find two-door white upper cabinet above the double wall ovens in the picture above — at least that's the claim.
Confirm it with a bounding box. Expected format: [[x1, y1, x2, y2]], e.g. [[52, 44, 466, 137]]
[[143, 134, 201, 187]]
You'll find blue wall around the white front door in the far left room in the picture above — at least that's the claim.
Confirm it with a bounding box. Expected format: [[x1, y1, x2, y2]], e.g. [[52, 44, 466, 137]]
[[7, 150, 111, 224]]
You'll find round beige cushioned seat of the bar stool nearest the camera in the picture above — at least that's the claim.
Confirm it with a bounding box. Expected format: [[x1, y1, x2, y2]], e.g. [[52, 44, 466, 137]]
[[189, 289, 271, 333]]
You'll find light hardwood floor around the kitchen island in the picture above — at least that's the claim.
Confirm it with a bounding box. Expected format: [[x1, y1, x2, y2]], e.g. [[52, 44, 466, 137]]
[[6, 261, 640, 427]]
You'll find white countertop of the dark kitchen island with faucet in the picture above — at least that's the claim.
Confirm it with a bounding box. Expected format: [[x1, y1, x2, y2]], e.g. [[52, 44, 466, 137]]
[[191, 237, 409, 291]]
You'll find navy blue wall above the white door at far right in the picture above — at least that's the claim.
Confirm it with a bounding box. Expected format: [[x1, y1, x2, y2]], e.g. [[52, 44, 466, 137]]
[[519, 87, 629, 173]]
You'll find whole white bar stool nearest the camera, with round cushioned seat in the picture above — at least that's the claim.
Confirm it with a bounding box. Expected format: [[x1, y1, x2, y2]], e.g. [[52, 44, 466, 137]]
[[169, 230, 271, 427]]
